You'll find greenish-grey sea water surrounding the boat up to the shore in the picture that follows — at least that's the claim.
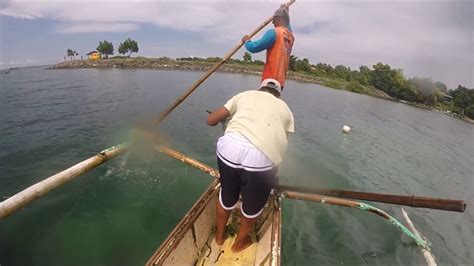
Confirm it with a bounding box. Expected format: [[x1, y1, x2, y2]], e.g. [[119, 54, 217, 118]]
[[0, 68, 474, 266]]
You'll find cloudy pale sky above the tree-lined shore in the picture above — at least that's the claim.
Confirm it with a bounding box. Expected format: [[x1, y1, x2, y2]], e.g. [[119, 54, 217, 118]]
[[0, 0, 474, 89]]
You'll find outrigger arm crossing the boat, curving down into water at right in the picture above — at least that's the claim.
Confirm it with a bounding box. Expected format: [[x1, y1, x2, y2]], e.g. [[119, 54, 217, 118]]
[[156, 146, 431, 251]]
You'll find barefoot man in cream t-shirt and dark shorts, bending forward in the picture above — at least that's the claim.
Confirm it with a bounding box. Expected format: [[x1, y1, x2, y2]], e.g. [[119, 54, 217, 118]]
[[207, 79, 295, 252]]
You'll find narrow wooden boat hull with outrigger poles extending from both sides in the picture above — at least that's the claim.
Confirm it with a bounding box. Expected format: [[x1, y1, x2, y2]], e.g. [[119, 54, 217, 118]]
[[142, 146, 466, 266]]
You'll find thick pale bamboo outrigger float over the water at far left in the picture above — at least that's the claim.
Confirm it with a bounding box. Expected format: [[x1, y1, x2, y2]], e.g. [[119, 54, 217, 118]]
[[0, 144, 127, 219]]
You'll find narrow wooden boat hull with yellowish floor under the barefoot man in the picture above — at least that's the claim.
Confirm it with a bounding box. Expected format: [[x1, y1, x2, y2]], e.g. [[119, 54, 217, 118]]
[[146, 179, 281, 266]]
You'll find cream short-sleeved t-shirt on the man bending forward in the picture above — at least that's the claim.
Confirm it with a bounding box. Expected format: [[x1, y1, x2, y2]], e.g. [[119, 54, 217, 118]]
[[224, 90, 295, 165]]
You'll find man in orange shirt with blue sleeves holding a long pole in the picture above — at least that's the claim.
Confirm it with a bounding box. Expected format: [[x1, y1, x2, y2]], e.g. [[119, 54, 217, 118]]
[[242, 5, 295, 89]]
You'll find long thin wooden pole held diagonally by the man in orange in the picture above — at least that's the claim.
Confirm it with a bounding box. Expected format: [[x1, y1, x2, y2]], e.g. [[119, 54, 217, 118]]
[[156, 0, 295, 124]]
